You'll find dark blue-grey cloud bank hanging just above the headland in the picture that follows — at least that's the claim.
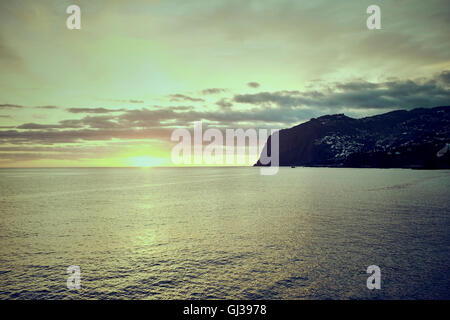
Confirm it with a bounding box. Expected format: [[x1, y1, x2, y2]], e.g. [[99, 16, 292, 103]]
[[233, 71, 450, 111]]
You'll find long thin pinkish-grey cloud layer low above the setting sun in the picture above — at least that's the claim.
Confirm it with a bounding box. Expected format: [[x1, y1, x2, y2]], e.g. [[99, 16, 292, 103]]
[[0, 103, 310, 144]]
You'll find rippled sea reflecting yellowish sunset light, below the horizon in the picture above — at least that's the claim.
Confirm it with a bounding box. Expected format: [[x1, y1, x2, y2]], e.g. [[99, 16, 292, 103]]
[[0, 168, 450, 299]]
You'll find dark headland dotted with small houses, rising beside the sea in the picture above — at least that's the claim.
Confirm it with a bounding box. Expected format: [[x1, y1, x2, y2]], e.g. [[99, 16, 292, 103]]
[[255, 107, 450, 168]]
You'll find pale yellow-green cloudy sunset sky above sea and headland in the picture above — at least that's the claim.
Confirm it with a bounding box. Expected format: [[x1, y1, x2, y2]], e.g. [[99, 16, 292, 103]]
[[0, 0, 450, 167]]
